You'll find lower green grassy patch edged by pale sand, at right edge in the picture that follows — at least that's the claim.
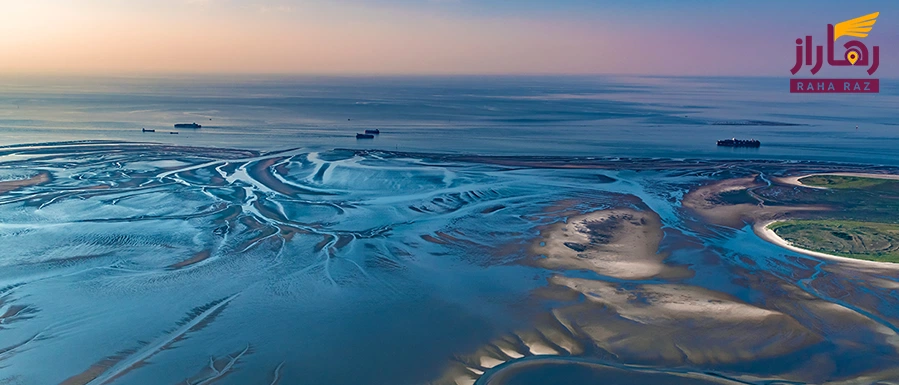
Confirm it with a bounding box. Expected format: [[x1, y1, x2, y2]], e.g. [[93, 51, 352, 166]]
[[768, 220, 899, 263]]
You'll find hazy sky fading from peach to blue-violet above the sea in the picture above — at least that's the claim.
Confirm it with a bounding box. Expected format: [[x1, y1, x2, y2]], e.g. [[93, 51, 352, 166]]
[[0, 0, 899, 77]]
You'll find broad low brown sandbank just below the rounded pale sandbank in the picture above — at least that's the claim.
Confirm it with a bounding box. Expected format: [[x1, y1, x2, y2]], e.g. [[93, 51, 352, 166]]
[[552, 276, 821, 366]]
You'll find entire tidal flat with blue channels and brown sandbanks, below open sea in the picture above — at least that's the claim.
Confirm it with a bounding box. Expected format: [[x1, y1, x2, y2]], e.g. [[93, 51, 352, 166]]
[[0, 142, 899, 385]]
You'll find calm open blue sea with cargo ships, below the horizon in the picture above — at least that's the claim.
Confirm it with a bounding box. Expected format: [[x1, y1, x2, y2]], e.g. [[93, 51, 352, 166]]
[[0, 77, 899, 165]]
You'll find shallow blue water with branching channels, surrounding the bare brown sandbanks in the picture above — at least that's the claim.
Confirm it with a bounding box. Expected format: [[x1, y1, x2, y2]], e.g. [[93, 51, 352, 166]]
[[0, 143, 899, 384]]
